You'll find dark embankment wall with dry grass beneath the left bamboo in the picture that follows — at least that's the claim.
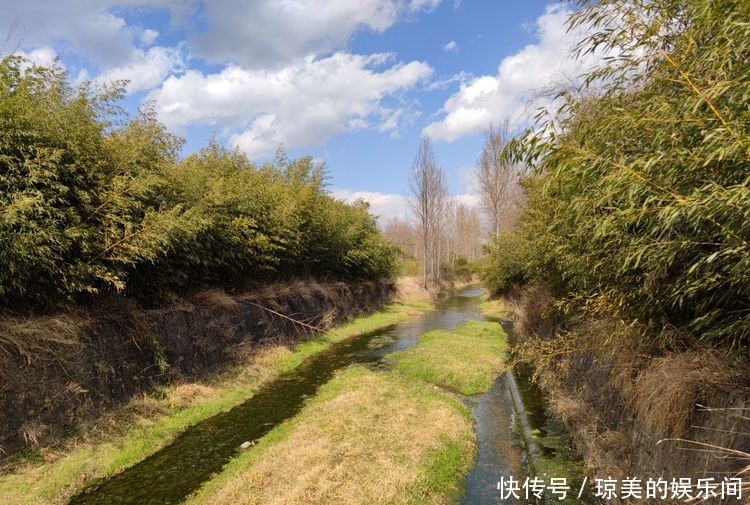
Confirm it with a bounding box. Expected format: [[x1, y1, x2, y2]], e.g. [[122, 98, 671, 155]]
[[0, 281, 394, 458]]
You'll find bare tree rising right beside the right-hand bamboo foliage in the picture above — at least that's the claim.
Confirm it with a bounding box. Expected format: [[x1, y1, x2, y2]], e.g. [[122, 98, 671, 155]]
[[475, 121, 516, 235]]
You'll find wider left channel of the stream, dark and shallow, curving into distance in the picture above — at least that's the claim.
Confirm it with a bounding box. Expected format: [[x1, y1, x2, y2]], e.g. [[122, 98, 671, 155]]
[[70, 288, 508, 505]]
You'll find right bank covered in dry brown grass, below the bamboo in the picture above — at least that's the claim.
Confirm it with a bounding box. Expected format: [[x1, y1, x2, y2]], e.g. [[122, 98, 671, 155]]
[[508, 289, 750, 503]]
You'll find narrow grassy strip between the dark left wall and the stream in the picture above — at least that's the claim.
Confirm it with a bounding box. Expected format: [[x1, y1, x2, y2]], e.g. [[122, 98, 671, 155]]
[[0, 296, 429, 505]]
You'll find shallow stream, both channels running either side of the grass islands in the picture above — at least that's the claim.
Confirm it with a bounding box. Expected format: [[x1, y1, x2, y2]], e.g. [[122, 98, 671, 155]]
[[69, 288, 576, 505]]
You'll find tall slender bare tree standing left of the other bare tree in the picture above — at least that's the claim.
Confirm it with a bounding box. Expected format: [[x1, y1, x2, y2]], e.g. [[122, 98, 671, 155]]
[[409, 137, 448, 285]]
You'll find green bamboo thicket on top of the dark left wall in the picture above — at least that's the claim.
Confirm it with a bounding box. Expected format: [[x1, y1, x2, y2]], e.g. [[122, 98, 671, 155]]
[[0, 56, 396, 310]]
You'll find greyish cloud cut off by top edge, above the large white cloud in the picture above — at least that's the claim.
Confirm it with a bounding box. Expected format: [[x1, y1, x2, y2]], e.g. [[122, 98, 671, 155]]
[[192, 0, 440, 69]]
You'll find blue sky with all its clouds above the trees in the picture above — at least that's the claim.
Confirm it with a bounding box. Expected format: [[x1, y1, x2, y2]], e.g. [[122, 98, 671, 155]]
[[0, 0, 590, 223]]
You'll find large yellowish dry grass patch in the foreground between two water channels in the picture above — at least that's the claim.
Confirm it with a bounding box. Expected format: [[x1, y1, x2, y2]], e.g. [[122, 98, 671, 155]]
[[188, 367, 475, 505]]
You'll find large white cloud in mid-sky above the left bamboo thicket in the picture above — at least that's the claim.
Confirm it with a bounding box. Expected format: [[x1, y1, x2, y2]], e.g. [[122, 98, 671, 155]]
[[149, 53, 432, 157]]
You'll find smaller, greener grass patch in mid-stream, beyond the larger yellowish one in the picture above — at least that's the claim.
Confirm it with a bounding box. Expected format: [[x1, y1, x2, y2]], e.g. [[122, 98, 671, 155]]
[[388, 321, 507, 395]]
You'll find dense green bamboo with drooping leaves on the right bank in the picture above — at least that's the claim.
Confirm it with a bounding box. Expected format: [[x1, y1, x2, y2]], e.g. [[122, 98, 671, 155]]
[[484, 0, 750, 346]]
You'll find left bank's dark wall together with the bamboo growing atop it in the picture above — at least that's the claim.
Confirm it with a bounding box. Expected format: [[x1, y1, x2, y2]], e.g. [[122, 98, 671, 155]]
[[0, 50, 406, 457]]
